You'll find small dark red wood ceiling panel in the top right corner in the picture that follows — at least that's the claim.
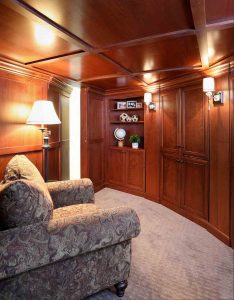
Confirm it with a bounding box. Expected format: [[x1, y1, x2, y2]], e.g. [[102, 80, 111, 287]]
[[206, 0, 234, 23]]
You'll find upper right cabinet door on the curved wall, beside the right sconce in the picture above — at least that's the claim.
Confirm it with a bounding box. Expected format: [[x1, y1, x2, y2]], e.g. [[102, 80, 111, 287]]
[[182, 86, 208, 158]]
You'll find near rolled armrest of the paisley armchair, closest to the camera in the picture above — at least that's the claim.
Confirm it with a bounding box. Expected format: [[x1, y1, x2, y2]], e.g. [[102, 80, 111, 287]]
[[0, 207, 140, 279]]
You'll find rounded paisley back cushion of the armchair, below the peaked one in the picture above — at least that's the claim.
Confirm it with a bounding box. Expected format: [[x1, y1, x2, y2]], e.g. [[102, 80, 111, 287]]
[[0, 180, 53, 229]]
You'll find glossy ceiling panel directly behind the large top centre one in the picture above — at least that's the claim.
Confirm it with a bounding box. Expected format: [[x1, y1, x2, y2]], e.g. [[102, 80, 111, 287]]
[[105, 36, 201, 72]]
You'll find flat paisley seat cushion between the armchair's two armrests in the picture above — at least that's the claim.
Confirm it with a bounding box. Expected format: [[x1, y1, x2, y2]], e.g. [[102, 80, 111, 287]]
[[53, 204, 98, 219]]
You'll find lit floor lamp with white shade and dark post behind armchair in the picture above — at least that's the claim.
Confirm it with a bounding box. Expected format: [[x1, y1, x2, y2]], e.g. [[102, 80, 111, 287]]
[[26, 100, 61, 182]]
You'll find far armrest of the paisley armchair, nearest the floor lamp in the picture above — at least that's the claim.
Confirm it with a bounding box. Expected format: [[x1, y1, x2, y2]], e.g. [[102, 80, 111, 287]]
[[46, 178, 94, 208]]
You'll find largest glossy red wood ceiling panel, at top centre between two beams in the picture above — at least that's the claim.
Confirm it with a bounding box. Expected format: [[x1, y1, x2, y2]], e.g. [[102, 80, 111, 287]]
[[25, 0, 193, 47]]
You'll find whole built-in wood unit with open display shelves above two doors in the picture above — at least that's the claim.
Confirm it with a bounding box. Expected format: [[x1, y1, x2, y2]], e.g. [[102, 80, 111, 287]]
[[106, 95, 145, 195]]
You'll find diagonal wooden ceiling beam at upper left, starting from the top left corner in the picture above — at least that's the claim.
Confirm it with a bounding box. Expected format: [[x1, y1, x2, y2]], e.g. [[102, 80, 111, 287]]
[[4, 0, 93, 52]]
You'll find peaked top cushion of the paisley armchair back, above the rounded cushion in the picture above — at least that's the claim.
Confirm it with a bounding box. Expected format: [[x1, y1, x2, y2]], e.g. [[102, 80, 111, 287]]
[[2, 155, 45, 185]]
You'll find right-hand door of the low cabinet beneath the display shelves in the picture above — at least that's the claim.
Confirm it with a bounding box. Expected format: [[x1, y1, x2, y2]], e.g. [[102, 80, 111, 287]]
[[125, 150, 145, 192]]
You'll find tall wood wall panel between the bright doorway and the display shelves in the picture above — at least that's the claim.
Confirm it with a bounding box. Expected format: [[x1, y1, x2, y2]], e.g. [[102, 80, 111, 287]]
[[81, 88, 105, 191]]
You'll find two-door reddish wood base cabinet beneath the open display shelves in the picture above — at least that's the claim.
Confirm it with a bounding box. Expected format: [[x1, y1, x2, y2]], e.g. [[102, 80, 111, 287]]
[[107, 146, 145, 192]]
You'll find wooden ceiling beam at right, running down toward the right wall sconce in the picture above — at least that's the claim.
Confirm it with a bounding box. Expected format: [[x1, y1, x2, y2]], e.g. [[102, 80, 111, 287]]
[[190, 0, 209, 68]]
